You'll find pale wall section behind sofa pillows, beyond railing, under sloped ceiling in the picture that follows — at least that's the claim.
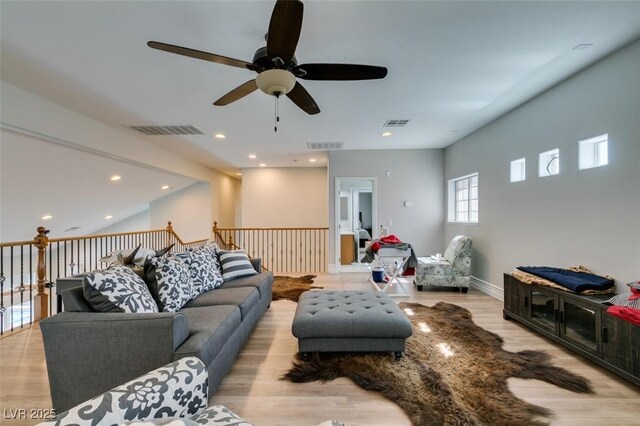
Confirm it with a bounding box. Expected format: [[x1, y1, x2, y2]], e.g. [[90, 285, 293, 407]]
[[149, 182, 213, 243]]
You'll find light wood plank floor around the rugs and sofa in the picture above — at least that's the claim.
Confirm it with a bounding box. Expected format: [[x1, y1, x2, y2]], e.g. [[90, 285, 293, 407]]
[[0, 273, 640, 426]]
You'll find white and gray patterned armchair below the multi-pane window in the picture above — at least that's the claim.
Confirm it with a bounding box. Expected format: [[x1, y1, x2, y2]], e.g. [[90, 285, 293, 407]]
[[414, 235, 471, 293]]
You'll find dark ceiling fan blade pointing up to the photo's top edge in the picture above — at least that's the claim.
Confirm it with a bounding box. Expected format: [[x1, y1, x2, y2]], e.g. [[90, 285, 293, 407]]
[[267, 0, 304, 63]]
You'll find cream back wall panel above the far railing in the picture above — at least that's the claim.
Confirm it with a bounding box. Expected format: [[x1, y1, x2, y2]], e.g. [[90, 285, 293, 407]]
[[242, 167, 328, 228]]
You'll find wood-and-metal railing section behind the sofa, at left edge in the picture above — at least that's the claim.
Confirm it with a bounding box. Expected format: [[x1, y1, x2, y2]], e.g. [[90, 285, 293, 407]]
[[0, 222, 208, 336]]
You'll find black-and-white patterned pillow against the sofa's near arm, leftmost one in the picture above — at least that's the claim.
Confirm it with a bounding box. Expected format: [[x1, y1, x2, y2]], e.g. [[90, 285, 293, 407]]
[[82, 266, 158, 313]]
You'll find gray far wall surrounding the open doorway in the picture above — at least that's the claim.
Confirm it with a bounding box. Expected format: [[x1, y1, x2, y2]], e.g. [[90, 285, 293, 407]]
[[329, 149, 444, 264]]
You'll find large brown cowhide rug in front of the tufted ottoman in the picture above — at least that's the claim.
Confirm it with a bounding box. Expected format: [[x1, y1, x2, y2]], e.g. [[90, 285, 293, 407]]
[[283, 302, 593, 425]]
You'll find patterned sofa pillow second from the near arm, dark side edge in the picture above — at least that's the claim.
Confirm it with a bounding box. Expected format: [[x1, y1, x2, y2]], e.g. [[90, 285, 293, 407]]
[[144, 256, 196, 312]]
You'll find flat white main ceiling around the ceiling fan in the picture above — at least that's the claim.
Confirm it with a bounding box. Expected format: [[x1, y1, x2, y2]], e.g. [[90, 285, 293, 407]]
[[1, 1, 640, 175]]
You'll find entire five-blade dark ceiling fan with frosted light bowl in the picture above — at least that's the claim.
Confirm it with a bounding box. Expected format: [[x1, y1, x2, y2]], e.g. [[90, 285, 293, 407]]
[[147, 0, 387, 114]]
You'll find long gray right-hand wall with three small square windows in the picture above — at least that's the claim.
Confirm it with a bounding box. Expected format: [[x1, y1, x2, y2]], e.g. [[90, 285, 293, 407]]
[[445, 42, 640, 291]]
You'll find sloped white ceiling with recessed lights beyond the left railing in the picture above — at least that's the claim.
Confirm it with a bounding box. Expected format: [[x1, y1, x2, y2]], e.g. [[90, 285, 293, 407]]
[[0, 130, 196, 242]]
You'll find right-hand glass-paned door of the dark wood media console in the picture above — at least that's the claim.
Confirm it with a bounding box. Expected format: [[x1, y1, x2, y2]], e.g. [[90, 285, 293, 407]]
[[558, 296, 602, 355]]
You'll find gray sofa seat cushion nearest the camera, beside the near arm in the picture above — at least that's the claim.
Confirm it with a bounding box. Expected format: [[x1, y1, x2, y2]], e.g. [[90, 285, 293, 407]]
[[173, 305, 242, 366]]
